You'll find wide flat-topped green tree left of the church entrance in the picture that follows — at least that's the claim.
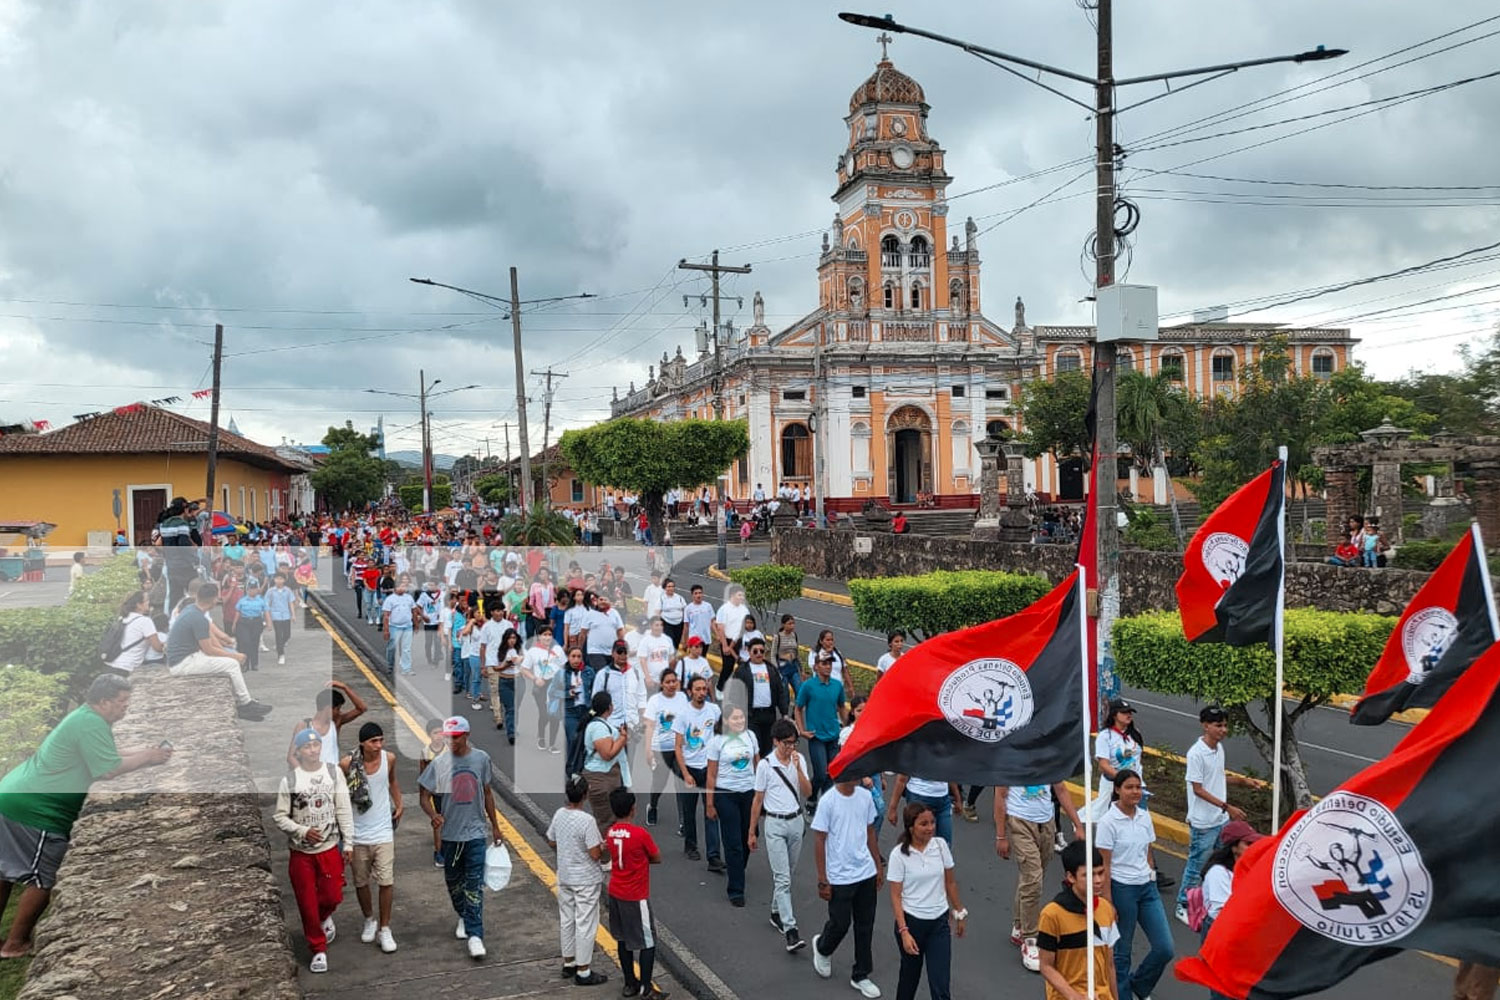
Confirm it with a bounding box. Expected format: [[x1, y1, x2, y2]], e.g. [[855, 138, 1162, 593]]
[[558, 417, 750, 551]]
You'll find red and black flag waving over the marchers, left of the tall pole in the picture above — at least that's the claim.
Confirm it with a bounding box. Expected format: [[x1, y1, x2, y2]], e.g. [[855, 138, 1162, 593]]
[[830, 571, 1085, 786]]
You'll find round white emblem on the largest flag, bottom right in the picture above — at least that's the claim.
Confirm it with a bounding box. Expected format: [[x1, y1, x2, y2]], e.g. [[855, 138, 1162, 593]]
[[1272, 792, 1433, 948]]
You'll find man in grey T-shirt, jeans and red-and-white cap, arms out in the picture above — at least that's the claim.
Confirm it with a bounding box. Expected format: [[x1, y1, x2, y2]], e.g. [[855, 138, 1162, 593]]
[[417, 715, 500, 960]]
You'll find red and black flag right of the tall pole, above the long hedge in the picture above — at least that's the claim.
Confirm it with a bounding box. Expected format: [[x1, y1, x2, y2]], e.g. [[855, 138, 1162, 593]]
[[1178, 460, 1287, 646]]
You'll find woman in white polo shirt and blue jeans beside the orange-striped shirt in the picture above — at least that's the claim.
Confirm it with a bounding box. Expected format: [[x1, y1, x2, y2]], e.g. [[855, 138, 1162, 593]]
[[1094, 769, 1173, 997]]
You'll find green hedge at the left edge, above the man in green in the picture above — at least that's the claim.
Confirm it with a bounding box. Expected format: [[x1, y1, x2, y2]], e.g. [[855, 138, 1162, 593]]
[[0, 555, 138, 703]]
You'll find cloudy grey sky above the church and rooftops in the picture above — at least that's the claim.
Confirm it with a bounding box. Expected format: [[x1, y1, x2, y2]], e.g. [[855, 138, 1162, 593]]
[[0, 0, 1500, 453]]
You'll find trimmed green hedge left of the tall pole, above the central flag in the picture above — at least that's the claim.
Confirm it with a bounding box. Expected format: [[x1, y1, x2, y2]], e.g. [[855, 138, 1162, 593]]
[[849, 570, 1052, 642]]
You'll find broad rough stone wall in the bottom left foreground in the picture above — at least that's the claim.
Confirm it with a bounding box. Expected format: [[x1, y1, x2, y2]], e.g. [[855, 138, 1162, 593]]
[[18, 672, 302, 1000]]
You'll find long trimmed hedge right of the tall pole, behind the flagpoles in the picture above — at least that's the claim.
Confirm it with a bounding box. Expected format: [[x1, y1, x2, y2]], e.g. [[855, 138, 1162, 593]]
[[1113, 609, 1397, 706]]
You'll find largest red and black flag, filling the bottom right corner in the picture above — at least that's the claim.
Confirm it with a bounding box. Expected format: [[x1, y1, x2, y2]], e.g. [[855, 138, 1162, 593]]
[[1176, 646, 1500, 1000]]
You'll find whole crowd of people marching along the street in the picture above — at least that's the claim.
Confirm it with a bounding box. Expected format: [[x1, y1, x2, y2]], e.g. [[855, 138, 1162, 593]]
[[0, 502, 1416, 1000]]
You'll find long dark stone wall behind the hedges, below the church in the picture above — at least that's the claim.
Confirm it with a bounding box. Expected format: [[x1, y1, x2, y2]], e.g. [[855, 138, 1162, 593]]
[[771, 531, 1428, 615]]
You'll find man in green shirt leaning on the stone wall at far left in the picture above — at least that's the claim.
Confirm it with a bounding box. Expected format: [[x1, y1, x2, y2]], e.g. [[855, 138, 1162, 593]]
[[0, 675, 173, 958]]
